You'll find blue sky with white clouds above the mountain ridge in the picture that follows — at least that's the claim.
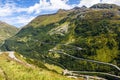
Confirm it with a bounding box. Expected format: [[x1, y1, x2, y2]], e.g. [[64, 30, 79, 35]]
[[0, 0, 120, 27]]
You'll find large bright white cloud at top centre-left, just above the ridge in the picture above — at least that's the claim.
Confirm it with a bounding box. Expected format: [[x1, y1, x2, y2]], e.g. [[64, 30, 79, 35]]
[[28, 0, 74, 14]]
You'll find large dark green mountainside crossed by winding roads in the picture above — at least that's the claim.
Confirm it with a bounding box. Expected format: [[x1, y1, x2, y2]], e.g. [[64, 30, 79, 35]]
[[2, 4, 120, 75]]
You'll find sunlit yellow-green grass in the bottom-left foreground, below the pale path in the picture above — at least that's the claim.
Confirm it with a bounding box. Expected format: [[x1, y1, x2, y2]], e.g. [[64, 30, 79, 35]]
[[0, 54, 78, 80]]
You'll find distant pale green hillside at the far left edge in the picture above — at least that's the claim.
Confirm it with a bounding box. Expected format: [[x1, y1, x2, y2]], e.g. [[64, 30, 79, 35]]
[[0, 21, 18, 43]]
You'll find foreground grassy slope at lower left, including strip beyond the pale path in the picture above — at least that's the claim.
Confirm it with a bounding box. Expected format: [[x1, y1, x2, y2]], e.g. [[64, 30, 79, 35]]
[[0, 53, 76, 80]]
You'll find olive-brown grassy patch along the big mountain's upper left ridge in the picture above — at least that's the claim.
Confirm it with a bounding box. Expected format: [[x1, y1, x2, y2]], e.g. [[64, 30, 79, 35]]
[[27, 11, 68, 27]]
